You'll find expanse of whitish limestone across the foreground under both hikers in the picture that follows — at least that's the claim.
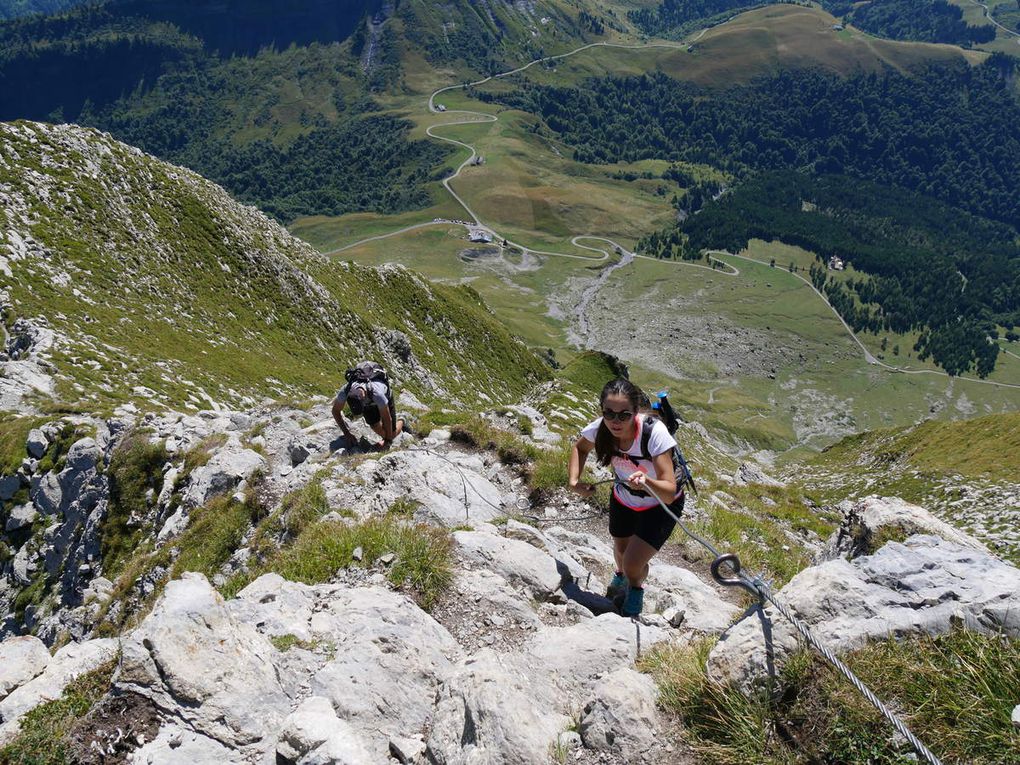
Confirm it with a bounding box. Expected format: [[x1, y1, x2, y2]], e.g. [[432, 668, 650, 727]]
[[0, 399, 1020, 765]]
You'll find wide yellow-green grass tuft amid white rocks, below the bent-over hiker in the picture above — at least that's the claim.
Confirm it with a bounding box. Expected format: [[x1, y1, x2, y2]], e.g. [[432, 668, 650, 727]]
[[238, 515, 453, 609]]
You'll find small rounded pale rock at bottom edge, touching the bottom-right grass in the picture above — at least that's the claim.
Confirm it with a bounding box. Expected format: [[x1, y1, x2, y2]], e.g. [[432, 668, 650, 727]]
[[580, 667, 659, 763]]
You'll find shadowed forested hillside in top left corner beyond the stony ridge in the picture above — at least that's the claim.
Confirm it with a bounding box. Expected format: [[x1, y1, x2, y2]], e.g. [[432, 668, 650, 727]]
[[0, 0, 605, 221]]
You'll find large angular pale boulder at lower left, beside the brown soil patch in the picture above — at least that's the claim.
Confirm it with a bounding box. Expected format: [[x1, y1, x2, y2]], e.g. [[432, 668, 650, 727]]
[[115, 573, 290, 748]]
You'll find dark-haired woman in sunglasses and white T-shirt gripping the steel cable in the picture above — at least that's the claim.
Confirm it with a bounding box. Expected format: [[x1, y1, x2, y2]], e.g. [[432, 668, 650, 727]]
[[567, 378, 683, 616]]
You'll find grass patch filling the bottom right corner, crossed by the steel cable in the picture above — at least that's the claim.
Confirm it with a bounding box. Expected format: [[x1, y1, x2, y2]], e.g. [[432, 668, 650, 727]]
[[639, 629, 1020, 765]]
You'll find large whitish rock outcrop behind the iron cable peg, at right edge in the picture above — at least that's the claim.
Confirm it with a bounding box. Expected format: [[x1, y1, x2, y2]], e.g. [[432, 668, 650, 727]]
[[708, 536, 1020, 687]]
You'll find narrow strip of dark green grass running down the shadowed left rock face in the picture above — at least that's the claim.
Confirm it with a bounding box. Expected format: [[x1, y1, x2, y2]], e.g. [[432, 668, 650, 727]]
[[100, 434, 168, 580]]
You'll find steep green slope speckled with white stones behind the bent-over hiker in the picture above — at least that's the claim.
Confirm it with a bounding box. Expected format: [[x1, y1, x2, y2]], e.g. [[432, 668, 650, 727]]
[[0, 122, 547, 416]]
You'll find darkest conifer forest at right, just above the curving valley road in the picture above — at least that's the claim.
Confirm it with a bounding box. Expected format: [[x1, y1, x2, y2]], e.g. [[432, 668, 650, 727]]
[[641, 171, 1020, 376]]
